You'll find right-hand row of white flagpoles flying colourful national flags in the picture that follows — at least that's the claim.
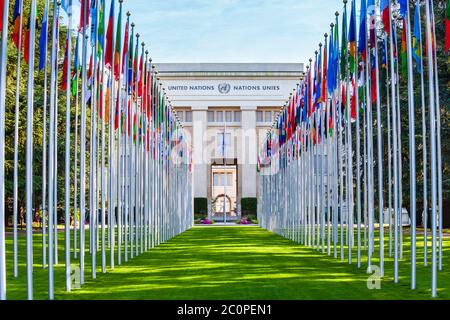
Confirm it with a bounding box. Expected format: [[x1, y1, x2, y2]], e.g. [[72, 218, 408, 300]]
[[258, 0, 444, 297]]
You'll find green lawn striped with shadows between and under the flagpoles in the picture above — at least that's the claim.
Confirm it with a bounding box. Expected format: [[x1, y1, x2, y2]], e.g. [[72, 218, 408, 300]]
[[3, 227, 450, 300]]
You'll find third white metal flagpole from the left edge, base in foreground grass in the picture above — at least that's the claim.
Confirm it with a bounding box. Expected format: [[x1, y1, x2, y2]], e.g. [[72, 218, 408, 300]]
[[26, 0, 36, 300]]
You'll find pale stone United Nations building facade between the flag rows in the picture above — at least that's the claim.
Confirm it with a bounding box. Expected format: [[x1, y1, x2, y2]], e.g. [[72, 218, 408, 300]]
[[156, 63, 303, 221]]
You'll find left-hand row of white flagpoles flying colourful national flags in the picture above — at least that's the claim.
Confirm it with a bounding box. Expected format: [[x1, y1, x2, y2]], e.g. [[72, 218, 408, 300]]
[[0, 0, 193, 300]]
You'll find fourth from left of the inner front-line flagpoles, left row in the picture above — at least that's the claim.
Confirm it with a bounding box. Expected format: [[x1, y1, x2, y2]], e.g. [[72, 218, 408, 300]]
[[64, 0, 72, 292]]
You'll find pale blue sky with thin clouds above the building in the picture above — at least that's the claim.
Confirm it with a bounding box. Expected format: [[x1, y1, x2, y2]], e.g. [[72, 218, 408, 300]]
[[67, 0, 343, 63]]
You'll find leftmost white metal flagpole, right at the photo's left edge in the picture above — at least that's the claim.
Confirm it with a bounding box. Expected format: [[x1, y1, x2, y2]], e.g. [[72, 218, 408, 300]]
[[0, 0, 9, 300]]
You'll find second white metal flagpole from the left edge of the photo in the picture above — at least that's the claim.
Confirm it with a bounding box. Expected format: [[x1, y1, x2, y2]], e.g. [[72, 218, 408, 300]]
[[13, 0, 24, 278]]
